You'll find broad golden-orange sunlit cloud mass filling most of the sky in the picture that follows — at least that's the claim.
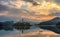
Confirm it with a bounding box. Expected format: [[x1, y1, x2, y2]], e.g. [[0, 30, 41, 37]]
[[0, 1, 60, 21]]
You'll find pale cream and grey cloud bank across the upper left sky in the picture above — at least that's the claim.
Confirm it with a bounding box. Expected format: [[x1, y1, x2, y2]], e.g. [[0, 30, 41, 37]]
[[0, 0, 32, 9]]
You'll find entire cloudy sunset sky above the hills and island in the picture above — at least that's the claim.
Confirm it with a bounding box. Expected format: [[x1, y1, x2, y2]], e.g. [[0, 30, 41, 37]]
[[0, 0, 60, 21]]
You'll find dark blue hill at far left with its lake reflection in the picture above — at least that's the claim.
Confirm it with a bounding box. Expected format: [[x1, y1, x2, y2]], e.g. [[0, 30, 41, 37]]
[[0, 21, 14, 31]]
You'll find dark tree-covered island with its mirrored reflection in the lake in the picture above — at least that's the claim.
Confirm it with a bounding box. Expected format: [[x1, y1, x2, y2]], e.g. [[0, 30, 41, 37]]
[[13, 22, 31, 33]]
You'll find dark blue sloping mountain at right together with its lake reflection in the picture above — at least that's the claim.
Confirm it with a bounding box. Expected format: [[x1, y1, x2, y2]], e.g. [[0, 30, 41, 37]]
[[38, 17, 60, 34]]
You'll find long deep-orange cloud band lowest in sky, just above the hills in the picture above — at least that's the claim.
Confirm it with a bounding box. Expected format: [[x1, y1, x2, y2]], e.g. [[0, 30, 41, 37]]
[[21, 16, 56, 21]]
